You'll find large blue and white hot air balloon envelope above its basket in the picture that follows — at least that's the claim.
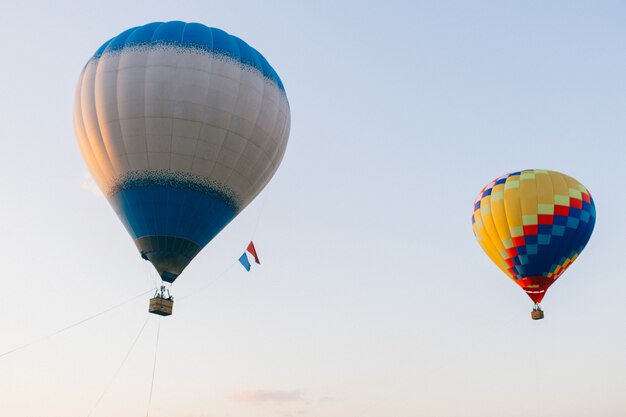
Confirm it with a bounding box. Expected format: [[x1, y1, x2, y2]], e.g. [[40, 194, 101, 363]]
[[73, 21, 290, 312]]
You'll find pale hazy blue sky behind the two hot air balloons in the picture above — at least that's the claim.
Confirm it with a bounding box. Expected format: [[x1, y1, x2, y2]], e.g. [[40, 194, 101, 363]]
[[0, 0, 626, 417]]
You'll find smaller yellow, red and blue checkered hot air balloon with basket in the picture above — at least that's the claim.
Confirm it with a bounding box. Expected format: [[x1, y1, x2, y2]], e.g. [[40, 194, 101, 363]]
[[472, 169, 596, 319]]
